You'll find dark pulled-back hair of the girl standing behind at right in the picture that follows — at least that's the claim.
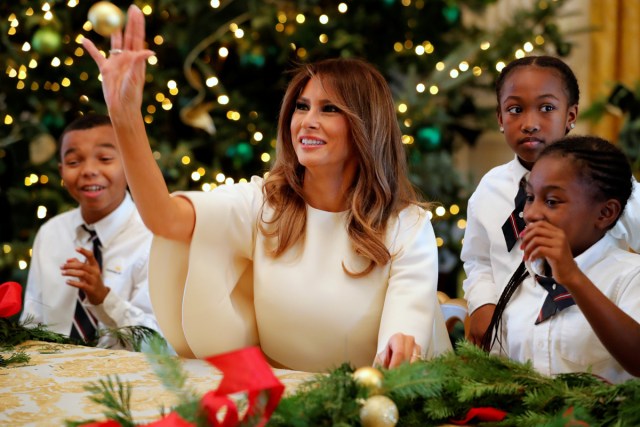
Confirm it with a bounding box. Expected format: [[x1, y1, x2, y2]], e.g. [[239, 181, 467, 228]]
[[495, 55, 580, 111]]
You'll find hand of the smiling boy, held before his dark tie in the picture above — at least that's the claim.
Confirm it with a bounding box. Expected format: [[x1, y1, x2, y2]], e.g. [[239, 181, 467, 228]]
[[60, 248, 110, 305]]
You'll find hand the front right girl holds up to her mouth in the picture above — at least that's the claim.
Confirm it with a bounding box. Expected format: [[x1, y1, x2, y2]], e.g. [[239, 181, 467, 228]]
[[521, 221, 582, 290]]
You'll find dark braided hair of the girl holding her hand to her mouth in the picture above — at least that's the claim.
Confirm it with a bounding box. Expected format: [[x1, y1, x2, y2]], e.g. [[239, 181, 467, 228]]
[[480, 136, 633, 351]]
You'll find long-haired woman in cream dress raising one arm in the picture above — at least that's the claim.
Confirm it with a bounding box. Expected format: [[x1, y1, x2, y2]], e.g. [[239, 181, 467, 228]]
[[84, 6, 451, 372]]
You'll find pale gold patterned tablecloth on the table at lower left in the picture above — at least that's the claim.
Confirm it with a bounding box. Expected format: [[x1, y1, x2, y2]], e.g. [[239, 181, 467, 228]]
[[0, 341, 310, 427]]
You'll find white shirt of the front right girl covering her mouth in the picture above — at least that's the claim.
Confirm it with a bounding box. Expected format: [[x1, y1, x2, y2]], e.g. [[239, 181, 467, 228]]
[[493, 235, 640, 383]]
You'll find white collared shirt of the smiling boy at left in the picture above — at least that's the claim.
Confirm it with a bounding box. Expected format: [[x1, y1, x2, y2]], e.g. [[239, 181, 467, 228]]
[[20, 193, 159, 347]]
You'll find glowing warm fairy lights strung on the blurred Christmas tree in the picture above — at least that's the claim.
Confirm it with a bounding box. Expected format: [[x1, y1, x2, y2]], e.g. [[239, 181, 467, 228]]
[[0, 0, 556, 270]]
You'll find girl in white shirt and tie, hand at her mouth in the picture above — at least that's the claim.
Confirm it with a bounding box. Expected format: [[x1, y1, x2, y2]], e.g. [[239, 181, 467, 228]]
[[482, 136, 640, 382]]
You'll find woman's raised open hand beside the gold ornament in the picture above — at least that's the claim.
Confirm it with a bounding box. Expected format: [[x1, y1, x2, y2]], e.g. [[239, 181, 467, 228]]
[[82, 5, 154, 119]]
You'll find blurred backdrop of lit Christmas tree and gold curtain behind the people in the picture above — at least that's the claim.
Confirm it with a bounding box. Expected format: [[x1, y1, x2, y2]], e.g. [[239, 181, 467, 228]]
[[0, 0, 640, 297]]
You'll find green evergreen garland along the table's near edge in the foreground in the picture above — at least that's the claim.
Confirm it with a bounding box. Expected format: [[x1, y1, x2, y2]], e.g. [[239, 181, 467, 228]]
[[30, 339, 640, 427]]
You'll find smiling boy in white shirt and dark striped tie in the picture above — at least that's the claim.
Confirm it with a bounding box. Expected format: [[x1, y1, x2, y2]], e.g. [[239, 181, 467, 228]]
[[21, 115, 159, 347]]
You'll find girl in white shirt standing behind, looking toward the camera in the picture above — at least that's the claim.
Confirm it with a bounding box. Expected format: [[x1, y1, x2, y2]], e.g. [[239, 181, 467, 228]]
[[460, 56, 640, 343]]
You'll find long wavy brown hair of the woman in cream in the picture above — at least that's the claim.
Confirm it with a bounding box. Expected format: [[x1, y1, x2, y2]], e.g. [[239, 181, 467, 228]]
[[259, 58, 419, 277]]
